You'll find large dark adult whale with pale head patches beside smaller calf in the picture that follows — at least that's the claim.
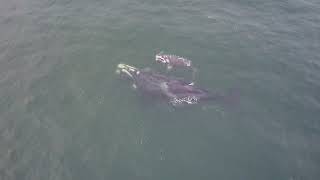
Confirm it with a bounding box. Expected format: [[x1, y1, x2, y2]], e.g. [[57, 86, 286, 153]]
[[116, 65, 218, 106]]
